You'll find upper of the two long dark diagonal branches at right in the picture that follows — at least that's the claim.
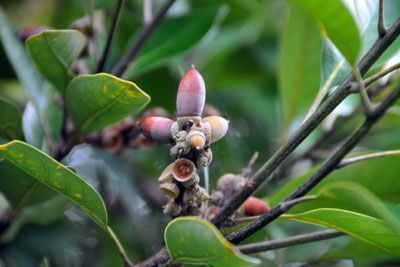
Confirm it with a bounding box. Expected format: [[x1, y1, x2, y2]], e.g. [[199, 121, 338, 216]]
[[212, 19, 400, 229]]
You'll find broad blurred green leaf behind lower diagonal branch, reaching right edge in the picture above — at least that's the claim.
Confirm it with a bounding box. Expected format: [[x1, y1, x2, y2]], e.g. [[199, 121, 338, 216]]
[[269, 155, 400, 206]]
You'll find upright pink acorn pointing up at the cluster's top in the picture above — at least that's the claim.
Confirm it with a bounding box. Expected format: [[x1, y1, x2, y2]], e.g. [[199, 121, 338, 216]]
[[176, 66, 206, 117]]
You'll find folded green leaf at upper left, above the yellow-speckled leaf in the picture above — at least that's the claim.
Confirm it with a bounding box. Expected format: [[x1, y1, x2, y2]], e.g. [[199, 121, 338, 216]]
[[26, 30, 85, 93]]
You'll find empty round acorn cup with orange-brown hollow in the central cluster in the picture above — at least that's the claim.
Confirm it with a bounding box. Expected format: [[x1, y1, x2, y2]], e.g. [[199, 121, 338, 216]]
[[172, 158, 200, 189]]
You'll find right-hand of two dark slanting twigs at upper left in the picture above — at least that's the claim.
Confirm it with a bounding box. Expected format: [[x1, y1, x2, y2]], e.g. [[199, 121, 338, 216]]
[[112, 0, 175, 77]]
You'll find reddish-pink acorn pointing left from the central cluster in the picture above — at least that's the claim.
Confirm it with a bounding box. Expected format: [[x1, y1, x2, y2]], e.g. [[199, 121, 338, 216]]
[[137, 117, 174, 144]]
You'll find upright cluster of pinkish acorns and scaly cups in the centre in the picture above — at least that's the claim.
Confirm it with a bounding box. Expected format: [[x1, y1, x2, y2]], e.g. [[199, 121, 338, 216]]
[[138, 67, 228, 217]]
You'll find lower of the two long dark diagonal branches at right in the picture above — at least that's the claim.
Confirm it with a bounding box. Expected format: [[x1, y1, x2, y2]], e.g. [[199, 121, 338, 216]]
[[227, 81, 400, 244]]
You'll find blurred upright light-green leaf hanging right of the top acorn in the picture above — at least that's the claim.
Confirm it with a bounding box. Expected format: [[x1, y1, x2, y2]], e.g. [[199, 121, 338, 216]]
[[279, 6, 322, 126]]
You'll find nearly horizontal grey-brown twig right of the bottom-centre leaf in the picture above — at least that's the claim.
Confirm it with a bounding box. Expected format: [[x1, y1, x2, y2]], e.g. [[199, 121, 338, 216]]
[[238, 229, 346, 254]]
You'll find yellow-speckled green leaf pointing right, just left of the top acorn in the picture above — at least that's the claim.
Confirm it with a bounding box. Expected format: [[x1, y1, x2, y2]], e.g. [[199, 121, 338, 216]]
[[65, 73, 150, 133]]
